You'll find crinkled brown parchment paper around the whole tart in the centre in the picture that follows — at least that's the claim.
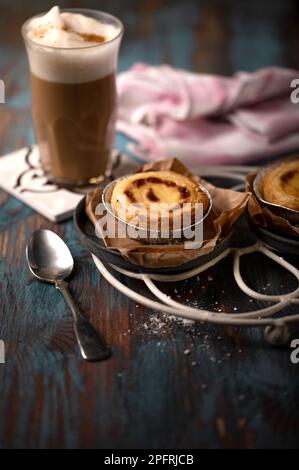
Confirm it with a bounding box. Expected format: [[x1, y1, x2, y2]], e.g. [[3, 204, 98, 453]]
[[86, 159, 251, 268]]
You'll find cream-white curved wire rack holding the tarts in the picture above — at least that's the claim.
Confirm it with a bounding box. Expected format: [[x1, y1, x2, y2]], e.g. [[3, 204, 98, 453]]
[[92, 166, 299, 346]]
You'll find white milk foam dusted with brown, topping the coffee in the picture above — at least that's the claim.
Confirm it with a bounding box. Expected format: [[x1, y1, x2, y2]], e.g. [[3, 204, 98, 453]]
[[23, 6, 121, 83]]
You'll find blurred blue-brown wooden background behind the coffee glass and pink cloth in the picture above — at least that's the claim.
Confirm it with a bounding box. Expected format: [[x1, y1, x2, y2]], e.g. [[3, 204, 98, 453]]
[[0, 0, 299, 153]]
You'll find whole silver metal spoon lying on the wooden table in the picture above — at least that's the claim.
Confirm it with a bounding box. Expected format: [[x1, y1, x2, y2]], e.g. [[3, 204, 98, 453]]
[[26, 230, 111, 361]]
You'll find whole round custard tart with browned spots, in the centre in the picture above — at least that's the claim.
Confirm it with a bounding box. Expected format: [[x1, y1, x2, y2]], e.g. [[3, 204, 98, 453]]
[[110, 171, 211, 242]]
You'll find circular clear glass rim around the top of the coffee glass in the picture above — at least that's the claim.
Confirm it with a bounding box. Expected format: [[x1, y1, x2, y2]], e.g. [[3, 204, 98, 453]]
[[21, 8, 125, 51]]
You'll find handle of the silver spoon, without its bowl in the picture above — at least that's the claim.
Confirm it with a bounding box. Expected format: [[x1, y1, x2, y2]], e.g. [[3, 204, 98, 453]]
[[55, 281, 111, 361]]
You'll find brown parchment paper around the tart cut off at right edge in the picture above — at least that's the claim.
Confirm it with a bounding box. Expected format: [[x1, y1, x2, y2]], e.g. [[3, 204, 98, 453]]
[[246, 172, 299, 237]]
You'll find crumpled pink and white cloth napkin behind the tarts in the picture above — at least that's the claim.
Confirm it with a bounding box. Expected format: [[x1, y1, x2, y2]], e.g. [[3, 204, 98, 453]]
[[117, 64, 299, 167]]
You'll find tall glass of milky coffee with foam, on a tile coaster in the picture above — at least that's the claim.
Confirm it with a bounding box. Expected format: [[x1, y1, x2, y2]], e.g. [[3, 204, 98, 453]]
[[22, 7, 123, 186]]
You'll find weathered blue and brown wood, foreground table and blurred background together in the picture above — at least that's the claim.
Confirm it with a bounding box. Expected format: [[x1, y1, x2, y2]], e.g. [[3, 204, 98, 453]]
[[0, 0, 299, 448]]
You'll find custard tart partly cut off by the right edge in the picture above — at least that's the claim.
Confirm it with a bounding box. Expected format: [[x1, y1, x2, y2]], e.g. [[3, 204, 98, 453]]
[[263, 157, 299, 211]]
